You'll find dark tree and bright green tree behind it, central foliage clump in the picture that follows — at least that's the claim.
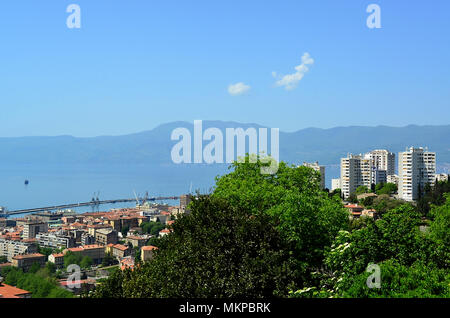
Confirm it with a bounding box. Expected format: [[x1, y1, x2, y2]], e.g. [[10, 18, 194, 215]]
[[96, 158, 348, 297]]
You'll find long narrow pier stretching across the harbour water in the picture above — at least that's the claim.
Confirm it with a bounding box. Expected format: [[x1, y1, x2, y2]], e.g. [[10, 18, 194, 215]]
[[2, 196, 179, 217]]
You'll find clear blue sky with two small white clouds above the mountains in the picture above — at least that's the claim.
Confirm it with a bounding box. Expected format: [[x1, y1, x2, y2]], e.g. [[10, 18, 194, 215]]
[[0, 0, 450, 137]]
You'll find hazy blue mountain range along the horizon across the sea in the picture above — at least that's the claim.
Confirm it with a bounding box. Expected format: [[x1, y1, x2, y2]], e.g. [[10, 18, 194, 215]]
[[0, 121, 450, 171]]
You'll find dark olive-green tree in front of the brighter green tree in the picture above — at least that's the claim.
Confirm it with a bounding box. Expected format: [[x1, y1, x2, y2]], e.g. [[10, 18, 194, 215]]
[[95, 196, 300, 297]]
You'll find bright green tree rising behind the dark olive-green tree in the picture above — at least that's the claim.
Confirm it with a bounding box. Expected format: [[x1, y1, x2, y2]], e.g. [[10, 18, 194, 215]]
[[212, 157, 348, 276]]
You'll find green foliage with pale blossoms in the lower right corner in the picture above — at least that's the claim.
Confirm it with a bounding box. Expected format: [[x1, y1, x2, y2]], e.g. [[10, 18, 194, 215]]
[[293, 197, 450, 297]]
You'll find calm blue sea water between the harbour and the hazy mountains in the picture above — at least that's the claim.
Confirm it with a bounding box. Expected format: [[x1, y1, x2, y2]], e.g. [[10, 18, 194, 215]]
[[0, 164, 339, 217]]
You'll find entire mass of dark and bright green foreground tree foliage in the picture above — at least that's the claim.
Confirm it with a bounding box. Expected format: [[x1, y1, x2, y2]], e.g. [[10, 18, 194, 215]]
[[89, 157, 450, 297]]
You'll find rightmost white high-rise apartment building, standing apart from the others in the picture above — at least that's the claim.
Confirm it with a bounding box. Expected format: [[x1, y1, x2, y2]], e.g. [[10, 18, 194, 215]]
[[398, 147, 436, 201]]
